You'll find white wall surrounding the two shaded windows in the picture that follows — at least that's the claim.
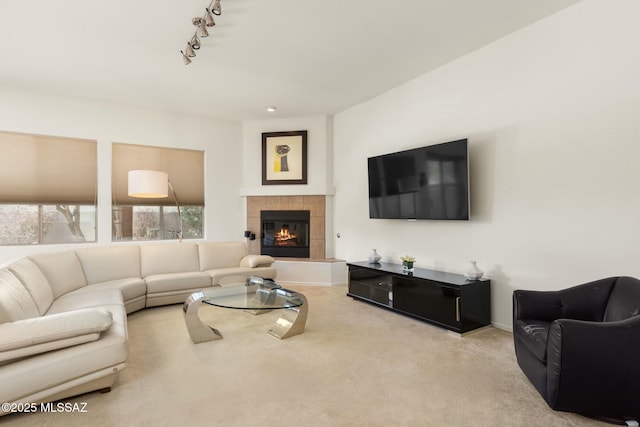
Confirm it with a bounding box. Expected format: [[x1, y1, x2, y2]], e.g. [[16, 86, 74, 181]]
[[0, 88, 244, 264]]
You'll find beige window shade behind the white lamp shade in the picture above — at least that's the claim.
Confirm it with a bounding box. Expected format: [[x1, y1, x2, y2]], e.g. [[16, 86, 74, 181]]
[[111, 142, 204, 206]]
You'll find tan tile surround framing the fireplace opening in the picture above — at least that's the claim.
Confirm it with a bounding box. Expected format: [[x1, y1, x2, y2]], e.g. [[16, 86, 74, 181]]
[[247, 196, 326, 260]]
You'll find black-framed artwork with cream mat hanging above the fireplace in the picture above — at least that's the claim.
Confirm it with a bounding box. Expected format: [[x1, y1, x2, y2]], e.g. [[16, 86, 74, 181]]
[[262, 130, 307, 185]]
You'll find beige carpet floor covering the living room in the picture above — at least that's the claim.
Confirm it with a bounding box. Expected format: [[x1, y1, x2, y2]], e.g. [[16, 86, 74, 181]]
[[0, 286, 609, 427]]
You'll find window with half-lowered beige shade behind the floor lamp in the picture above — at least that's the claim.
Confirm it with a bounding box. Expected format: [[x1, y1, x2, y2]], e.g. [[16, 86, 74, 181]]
[[112, 143, 204, 241]]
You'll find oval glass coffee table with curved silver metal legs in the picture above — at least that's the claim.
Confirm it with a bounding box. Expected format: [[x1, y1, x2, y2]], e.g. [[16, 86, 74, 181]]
[[183, 276, 309, 344]]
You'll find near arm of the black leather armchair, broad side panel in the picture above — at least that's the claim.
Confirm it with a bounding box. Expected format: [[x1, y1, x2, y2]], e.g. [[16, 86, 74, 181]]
[[547, 316, 640, 415]]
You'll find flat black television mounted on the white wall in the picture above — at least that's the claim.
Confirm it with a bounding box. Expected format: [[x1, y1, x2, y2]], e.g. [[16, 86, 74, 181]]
[[368, 139, 469, 220]]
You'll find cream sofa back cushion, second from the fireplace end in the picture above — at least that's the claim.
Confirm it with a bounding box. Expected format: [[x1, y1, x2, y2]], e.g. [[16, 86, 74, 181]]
[[140, 242, 200, 277]]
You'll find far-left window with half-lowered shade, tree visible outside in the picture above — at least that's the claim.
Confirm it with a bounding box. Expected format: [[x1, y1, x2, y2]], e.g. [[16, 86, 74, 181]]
[[0, 132, 97, 245]]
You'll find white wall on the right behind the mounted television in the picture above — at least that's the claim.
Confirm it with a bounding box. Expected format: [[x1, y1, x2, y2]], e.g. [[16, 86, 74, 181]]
[[334, 0, 640, 329]]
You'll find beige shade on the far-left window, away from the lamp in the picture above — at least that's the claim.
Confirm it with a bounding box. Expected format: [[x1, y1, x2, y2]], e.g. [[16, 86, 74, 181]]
[[0, 131, 97, 205]]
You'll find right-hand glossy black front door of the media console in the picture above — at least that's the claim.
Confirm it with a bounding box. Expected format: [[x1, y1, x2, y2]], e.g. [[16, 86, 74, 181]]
[[393, 277, 461, 330]]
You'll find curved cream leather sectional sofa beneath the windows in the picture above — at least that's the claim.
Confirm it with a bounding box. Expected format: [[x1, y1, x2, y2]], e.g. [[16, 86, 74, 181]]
[[0, 242, 276, 415]]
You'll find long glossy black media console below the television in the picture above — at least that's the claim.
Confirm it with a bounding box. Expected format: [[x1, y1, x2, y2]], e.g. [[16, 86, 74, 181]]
[[347, 261, 491, 334]]
